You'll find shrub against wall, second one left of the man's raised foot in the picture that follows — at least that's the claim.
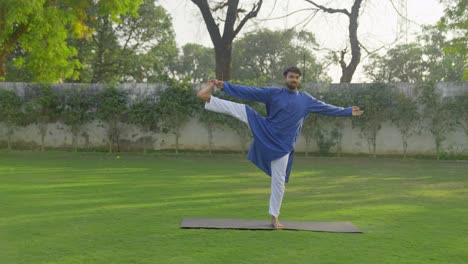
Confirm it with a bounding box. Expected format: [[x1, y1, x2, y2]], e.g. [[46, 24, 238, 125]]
[[128, 92, 160, 153]]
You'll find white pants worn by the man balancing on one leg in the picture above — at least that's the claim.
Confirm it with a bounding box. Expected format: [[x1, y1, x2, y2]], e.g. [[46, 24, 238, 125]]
[[205, 96, 289, 217]]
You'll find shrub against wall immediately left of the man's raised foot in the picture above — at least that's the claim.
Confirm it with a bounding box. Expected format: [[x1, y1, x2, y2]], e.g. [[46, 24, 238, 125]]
[[158, 79, 200, 154]]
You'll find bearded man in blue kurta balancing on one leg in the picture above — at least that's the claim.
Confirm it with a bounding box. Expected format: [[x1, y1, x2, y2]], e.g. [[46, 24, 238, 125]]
[[197, 67, 363, 229]]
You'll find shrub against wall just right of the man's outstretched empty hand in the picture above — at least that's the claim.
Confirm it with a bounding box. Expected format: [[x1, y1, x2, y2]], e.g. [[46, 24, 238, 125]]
[[352, 84, 396, 157]]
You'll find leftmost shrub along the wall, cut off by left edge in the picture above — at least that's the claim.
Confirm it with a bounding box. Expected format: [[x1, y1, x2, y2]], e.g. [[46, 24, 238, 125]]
[[0, 89, 23, 150]]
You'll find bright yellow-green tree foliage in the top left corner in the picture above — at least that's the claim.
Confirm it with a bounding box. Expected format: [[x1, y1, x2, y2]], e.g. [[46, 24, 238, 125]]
[[0, 0, 141, 82]]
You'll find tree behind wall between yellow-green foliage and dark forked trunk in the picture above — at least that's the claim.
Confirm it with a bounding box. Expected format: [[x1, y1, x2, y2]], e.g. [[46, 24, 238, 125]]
[[72, 0, 177, 83]]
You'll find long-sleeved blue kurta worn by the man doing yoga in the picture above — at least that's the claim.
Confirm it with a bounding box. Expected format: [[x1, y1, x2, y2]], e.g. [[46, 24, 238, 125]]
[[223, 82, 352, 182]]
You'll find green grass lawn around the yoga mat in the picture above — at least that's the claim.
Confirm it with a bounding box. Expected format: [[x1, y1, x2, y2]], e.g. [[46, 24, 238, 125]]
[[0, 152, 468, 264]]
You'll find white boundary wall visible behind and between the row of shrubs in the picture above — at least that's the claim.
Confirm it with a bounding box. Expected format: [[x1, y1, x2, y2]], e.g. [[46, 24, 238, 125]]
[[0, 83, 468, 155]]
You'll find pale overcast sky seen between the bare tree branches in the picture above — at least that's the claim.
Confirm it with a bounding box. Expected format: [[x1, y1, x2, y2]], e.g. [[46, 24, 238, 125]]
[[159, 0, 443, 82]]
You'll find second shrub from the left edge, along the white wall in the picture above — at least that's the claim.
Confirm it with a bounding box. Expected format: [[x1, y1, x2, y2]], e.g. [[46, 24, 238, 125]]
[[26, 85, 62, 151]]
